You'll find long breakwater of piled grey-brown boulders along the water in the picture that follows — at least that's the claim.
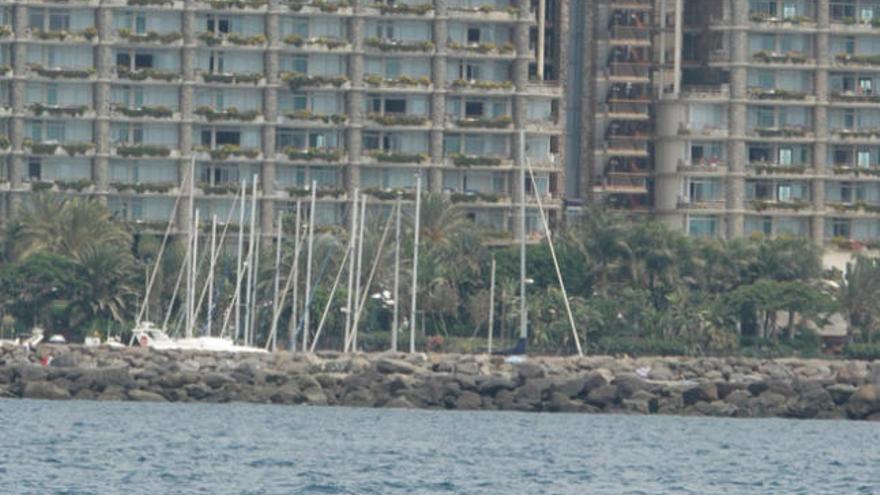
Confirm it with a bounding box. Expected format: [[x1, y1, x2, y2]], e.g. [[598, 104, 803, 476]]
[[0, 345, 880, 421]]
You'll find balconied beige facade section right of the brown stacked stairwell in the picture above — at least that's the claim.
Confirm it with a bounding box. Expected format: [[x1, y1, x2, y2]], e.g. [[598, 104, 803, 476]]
[[655, 0, 880, 245]]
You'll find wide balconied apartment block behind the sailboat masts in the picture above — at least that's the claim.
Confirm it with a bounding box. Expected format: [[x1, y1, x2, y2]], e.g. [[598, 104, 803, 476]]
[[0, 0, 569, 236]]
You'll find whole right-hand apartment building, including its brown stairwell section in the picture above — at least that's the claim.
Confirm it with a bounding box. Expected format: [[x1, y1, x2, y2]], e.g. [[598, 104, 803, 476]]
[[567, 0, 880, 248]]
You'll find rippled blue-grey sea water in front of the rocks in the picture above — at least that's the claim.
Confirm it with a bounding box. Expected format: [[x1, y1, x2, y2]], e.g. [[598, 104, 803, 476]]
[[0, 399, 880, 495]]
